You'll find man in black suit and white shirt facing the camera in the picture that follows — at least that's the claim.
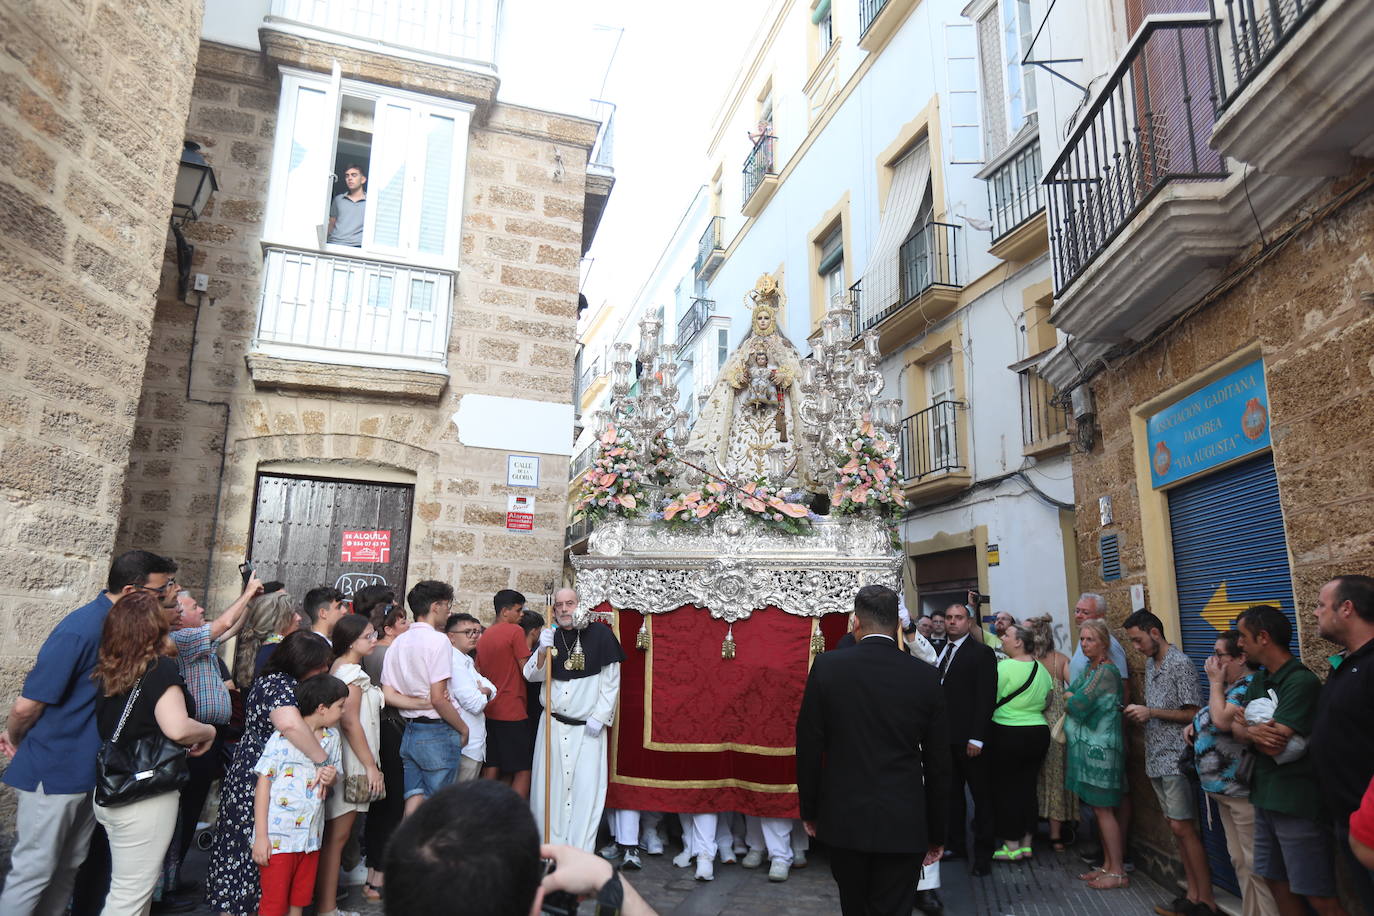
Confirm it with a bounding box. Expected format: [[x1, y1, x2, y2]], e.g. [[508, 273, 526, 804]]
[[936, 604, 998, 876]]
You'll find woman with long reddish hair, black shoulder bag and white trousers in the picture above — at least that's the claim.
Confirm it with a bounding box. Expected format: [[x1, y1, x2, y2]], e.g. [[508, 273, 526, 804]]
[[91, 592, 214, 916]]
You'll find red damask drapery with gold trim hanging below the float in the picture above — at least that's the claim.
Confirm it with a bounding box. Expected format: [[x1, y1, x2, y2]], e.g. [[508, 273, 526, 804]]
[[596, 604, 848, 817]]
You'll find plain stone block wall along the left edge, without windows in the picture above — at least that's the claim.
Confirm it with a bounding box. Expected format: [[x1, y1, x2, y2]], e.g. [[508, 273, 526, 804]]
[[0, 0, 203, 834]]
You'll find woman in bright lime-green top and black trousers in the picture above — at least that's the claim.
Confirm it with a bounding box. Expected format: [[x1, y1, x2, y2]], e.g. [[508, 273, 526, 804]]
[[988, 623, 1054, 862]]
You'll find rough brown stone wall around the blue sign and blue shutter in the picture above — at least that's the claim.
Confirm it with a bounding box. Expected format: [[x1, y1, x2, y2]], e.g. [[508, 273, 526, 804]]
[[1073, 168, 1374, 875]]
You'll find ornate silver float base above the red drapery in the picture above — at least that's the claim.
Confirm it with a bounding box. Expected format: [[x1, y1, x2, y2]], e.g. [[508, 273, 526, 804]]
[[572, 509, 901, 626]]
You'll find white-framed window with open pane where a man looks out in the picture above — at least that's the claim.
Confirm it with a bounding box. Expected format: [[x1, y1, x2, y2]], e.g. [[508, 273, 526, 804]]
[[264, 70, 473, 269]]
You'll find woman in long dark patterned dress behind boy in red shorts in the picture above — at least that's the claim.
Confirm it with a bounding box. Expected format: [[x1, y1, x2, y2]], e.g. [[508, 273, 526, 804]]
[[205, 630, 334, 916]]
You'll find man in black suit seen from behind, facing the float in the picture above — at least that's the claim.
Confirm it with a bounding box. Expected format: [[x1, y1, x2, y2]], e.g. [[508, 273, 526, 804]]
[[797, 585, 949, 916]]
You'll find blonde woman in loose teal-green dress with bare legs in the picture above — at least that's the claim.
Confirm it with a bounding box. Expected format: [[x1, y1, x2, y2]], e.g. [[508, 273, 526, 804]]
[[1063, 619, 1131, 890]]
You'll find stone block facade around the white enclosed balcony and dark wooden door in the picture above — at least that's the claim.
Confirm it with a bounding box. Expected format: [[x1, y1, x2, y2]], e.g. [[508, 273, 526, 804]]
[[120, 43, 595, 619]]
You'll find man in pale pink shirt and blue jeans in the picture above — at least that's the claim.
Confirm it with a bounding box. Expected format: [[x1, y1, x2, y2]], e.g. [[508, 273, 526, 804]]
[[382, 580, 467, 814]]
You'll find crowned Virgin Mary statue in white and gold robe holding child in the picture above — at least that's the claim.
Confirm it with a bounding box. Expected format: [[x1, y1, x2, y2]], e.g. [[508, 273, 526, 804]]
[[687, 273, 812, 488]]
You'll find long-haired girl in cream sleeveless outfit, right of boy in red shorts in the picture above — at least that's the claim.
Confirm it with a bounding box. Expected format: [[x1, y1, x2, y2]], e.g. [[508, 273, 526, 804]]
[[315, 614, 401, 916]]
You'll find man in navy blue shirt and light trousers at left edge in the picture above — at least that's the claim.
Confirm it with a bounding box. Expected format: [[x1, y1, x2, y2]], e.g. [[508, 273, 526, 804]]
[[0, 551, 176, 916]]
